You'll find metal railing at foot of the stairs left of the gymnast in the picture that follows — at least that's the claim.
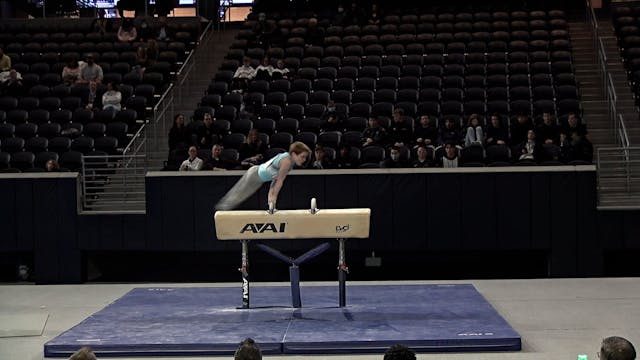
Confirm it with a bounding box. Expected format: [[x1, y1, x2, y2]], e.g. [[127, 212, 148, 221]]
[[80, 155, 147, 213]]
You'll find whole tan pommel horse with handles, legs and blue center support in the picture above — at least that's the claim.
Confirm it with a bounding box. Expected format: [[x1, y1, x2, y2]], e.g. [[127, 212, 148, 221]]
[[214, 198, 371, 309]]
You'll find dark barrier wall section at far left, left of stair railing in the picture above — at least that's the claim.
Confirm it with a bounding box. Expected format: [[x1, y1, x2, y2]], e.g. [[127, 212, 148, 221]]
[[0, 173, 82, 283]]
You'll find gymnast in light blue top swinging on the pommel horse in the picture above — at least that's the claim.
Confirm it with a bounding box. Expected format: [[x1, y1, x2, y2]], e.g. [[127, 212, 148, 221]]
[[216, 141, 311, 210]]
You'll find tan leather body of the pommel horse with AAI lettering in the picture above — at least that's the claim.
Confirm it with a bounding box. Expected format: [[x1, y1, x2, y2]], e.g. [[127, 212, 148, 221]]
[[214, 208, 371, 240]]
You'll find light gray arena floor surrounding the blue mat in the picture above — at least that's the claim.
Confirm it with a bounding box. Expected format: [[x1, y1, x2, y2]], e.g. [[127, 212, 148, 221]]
[[0, 278, 640, 360]]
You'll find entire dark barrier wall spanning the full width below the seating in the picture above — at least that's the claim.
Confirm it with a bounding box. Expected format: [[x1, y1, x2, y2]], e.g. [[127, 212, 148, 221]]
[[5, 167, 640, 283]]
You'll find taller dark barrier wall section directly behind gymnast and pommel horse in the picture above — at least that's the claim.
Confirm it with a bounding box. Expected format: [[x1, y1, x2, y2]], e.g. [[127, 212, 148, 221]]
[[146, 167, 602, 276]]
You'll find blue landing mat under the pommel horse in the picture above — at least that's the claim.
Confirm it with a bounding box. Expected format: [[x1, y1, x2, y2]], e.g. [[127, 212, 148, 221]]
[[44, 284, 521, 357]]
